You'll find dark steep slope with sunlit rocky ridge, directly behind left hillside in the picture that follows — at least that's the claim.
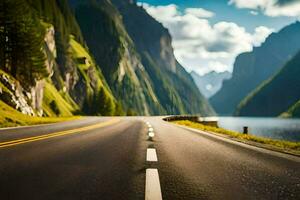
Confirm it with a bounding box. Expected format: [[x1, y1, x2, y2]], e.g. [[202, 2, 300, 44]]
[[76, 0, 159, 115]]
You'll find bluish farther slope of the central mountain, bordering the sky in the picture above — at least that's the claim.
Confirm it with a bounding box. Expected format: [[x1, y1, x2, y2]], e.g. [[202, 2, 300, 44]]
[[112, 0, 214, 115]]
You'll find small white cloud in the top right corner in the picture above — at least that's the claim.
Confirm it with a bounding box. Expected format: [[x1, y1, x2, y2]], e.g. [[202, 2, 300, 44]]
[[229, 0, 300, 17]]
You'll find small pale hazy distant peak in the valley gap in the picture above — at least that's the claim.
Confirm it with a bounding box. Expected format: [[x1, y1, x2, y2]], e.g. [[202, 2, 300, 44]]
[[190, 71, 231, 98]]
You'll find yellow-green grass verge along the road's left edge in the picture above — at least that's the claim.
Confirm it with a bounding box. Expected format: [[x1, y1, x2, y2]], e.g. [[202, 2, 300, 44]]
[[0, 100, 80, 128]]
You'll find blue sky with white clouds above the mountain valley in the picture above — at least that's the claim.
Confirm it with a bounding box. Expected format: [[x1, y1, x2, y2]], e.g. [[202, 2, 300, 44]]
[[138, 0, 300, 75]]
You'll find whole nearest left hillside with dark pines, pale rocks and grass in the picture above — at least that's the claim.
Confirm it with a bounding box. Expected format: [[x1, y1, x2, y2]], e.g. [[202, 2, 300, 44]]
[[0, 0, 122, 119]]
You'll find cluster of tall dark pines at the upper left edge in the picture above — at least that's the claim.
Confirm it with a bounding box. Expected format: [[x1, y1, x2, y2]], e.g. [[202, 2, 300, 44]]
[[0, 0, 48, 87]]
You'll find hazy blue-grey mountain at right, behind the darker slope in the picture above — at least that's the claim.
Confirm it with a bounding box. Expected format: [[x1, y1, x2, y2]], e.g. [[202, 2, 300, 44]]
[[210, 22, 300, 115]]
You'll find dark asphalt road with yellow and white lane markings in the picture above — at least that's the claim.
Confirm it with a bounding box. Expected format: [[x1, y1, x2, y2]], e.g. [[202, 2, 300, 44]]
[[0, 117, 300, 200]]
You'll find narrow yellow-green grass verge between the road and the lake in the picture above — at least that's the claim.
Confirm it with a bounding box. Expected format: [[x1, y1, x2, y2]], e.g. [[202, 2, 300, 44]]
[[173, 120, 300, 155]]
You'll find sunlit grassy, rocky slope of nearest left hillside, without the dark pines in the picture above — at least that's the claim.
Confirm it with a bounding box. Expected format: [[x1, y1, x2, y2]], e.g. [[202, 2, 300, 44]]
[[0, 0, 122, 116]]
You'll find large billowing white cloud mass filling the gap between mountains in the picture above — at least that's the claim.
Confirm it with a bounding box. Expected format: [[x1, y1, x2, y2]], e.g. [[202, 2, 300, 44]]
[[139, 3, 272, 74]]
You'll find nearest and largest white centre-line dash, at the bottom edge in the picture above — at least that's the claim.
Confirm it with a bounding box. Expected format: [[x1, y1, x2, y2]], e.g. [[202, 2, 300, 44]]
[[145, 169, 162, 200]]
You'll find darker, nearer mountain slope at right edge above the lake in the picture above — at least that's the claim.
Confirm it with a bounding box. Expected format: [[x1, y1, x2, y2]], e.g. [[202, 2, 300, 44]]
[[236, 52, 300, 116]]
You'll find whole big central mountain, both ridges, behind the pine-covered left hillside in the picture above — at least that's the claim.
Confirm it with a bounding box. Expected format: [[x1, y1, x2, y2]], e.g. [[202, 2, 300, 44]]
[[73, 0, 213, 115]]
